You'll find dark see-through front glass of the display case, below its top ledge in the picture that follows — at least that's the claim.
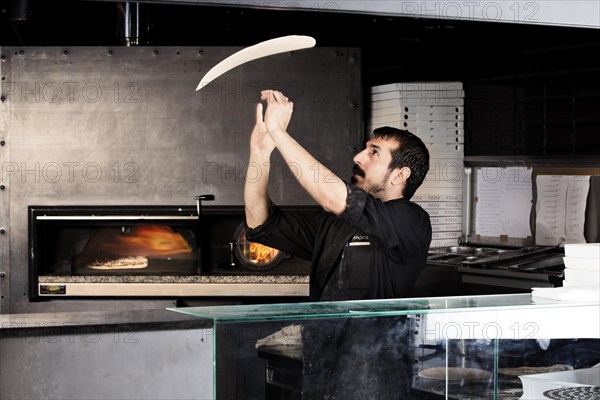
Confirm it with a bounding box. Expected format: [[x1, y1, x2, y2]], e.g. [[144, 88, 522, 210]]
[[215, 314, 600, 400]]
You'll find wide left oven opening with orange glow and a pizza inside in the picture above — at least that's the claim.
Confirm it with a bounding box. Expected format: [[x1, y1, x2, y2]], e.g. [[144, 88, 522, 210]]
[[30, 207, 201, 280]]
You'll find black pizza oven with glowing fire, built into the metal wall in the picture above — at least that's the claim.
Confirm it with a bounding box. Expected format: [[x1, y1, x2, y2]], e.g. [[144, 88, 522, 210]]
[[29, 203, 310, 300]]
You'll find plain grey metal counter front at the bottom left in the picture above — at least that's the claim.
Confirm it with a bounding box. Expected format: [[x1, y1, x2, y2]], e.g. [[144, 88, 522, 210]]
[[0, 328, 213, 400]]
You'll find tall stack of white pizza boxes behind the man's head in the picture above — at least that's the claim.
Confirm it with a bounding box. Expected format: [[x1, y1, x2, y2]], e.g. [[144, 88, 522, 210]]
[[366, 82, 464, 248]]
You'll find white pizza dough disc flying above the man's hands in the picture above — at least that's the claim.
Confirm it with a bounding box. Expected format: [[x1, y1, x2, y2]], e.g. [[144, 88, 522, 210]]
[[196, 35, 317, 91]]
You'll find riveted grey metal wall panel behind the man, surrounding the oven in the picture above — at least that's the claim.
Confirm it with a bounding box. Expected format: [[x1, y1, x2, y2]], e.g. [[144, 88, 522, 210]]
[[0, 47, 363, 312]]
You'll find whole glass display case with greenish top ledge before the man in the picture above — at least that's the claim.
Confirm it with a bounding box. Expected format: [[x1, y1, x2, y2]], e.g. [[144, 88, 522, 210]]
[[171, 294, 600, 400]]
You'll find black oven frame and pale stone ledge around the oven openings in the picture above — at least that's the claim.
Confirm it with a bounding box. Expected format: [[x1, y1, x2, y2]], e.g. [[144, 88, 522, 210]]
[[28, 205, 312, 301]]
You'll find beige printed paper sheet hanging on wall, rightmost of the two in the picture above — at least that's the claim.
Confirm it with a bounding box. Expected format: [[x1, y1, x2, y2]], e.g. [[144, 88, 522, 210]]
[[535, 175, 590, 246]]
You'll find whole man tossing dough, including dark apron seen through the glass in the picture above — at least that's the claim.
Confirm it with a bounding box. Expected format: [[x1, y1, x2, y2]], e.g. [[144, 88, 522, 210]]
[[244, 90, 431, 400]]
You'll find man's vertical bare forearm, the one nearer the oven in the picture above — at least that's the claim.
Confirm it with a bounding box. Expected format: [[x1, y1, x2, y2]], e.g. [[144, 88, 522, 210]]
[[244, 151, 270, 228]]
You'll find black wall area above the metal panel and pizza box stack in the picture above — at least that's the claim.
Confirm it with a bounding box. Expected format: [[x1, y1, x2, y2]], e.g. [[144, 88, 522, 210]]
[[0, 0, 600, 157]]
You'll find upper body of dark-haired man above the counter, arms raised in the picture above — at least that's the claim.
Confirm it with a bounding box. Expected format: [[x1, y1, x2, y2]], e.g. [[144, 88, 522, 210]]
[[244, 90, 431, 301]]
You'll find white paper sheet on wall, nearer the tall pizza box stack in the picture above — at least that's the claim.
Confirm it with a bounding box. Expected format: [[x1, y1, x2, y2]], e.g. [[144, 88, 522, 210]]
[[475, 167, 533, 238]]
